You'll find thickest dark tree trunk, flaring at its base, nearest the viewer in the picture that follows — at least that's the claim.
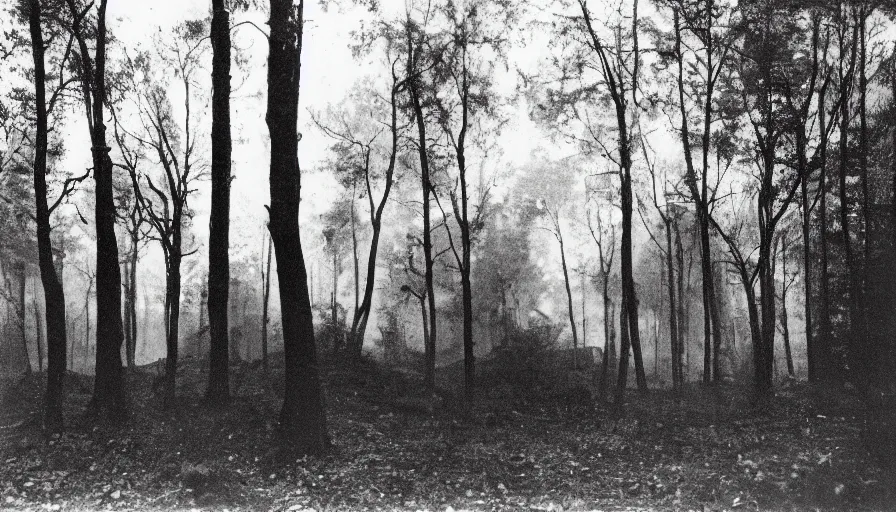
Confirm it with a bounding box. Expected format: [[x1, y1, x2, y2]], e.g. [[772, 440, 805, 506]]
[[266, 0, 327, 453]]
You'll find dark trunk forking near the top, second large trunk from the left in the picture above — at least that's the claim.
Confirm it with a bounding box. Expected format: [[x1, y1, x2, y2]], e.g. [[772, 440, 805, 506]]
[[67, 0, 125, 422]]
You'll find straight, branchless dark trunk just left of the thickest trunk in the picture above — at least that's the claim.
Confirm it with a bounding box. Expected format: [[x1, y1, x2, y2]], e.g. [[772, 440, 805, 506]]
[[205, 0, 233, 403]]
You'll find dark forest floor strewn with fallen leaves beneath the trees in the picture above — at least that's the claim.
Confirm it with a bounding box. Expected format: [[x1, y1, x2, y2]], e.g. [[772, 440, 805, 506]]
[[0, 361, 896, 511]]
